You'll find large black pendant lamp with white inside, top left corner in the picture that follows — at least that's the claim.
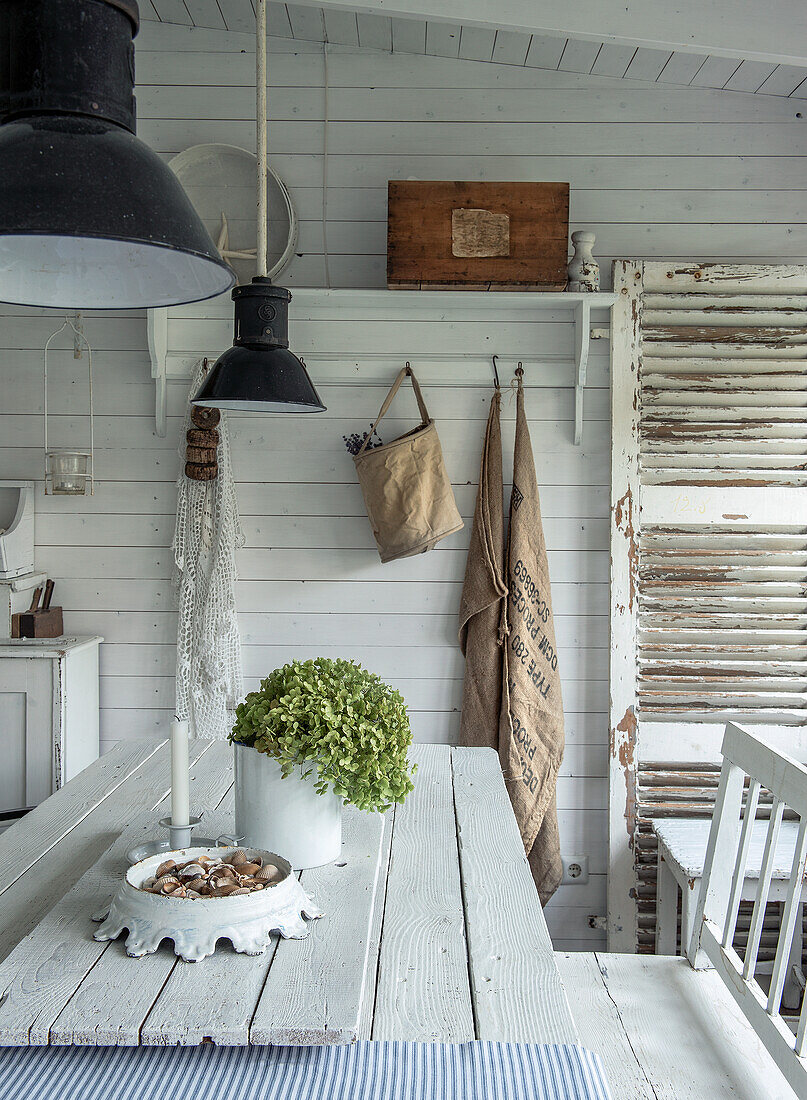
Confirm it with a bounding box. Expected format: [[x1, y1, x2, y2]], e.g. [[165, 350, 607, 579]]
[[0, 0, 235, 309]]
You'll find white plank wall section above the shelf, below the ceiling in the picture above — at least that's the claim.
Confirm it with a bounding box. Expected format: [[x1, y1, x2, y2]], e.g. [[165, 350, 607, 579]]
[[136, 23, 807, 286]]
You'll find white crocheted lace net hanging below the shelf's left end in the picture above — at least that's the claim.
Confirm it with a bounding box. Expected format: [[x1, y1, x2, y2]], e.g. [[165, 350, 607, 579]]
[[173, 360, 244, 738]]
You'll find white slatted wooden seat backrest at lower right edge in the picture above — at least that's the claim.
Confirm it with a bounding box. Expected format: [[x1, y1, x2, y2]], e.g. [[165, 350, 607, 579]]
[[687, 724, 807, 1098]]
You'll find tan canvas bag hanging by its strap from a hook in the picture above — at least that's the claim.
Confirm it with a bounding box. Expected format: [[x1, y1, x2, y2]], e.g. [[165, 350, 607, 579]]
[[353, 363, 463, 562]]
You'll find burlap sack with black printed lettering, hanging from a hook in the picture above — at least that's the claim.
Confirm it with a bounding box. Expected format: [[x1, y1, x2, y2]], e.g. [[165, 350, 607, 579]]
[[499, 377, 564, 904]]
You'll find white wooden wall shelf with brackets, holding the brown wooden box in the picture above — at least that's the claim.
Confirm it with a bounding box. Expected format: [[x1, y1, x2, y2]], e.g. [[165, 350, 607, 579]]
[[148, 287, 616, 444]]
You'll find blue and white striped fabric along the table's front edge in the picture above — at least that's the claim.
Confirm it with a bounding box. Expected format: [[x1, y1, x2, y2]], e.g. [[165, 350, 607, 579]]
[[0, 1042, 610, 1100]]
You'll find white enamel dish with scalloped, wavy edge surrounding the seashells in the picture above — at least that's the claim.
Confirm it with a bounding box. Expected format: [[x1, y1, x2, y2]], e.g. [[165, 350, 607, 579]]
[[93, 848, 323, 963]]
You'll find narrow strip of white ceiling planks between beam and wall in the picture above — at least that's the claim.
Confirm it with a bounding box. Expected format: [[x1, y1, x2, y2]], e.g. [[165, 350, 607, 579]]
[[141, 0, 807, 99]]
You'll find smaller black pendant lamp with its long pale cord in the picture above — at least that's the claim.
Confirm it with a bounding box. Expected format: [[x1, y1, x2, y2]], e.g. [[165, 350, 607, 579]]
[[192, 0, 325, 413]]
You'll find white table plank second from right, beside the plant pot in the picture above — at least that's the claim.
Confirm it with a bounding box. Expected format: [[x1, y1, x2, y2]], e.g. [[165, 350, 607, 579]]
[[373, 745, 474, 1043]]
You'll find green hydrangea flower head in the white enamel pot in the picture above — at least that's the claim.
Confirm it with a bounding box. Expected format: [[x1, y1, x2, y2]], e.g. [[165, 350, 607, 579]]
[[230, 657, 414, 811]]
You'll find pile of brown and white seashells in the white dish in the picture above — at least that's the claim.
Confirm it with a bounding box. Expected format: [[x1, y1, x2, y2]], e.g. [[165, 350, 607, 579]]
[[140, 848, 283, 900]]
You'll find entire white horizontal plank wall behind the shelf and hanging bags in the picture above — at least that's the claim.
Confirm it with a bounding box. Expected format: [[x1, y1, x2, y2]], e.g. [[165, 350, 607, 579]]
[[0, 25, 807, 948]]
